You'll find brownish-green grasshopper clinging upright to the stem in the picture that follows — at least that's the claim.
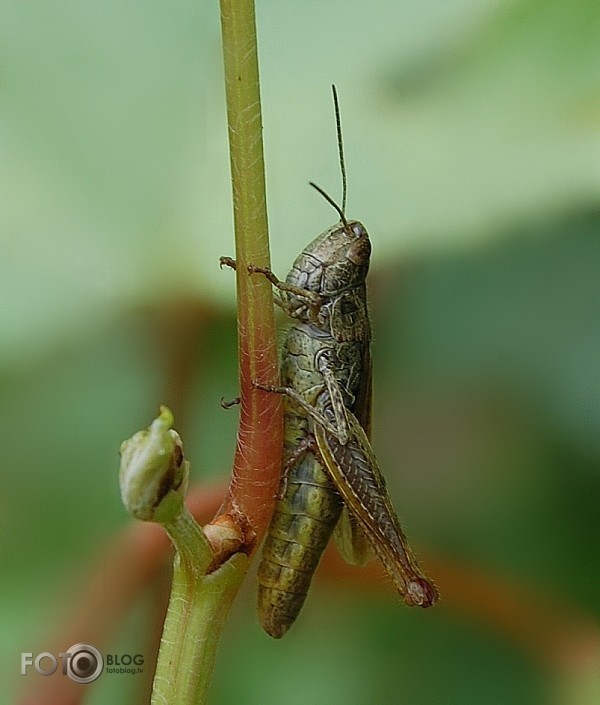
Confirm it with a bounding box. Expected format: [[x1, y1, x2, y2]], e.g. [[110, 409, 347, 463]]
[[227, 86, 438, 638]]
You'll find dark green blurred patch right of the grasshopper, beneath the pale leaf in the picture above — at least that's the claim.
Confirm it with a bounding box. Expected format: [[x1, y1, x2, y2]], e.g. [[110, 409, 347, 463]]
[[373, 213, 600, 614]]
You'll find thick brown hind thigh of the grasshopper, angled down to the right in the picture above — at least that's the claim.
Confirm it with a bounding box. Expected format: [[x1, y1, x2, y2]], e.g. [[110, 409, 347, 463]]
[[315, 404, 438, 607]]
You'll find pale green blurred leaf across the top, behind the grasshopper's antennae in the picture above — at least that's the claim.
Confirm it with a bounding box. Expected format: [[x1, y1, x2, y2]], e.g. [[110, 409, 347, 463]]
[[0, 0, 600, 364]]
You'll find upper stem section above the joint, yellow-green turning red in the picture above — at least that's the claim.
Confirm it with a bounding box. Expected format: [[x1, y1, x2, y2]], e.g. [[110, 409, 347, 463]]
[[221, 0, 283, 544]]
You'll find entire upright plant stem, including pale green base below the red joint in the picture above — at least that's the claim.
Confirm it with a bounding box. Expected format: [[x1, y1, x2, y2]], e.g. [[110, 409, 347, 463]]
[[152, 0, 283, 705]]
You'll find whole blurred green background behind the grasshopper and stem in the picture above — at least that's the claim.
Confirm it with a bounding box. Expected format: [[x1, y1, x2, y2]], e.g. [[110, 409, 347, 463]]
[[0, 0, 600, 705]]
